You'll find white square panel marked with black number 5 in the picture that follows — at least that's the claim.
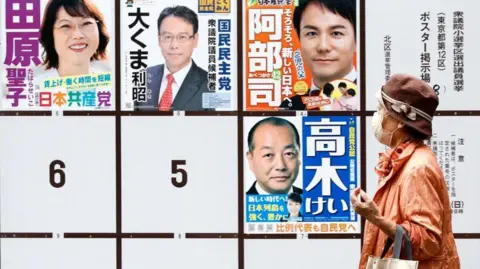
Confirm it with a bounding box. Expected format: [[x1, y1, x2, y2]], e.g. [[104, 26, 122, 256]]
[[122, 117, 238, 233]]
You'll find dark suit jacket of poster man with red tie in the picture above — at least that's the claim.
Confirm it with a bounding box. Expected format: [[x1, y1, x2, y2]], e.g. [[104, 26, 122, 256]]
[[135, 61, 214, 111]]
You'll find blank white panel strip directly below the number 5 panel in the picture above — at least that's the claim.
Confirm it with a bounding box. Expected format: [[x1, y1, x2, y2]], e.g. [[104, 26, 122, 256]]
[[122, 239, 238, 269]]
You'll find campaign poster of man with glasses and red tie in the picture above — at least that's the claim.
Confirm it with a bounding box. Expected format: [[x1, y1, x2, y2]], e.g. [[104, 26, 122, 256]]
[[121, 0, 237, 111]]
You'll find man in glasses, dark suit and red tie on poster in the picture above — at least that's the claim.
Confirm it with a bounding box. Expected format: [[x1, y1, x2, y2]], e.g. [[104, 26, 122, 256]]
[[135, 5, 209, 111]]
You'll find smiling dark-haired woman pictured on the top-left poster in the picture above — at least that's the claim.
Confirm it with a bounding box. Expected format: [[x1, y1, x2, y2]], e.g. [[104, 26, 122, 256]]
[[35, 0, 113, 80]]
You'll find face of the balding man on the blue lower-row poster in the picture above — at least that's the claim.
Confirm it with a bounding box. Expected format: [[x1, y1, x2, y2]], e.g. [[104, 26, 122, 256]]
[[247, 124, 300, 194]]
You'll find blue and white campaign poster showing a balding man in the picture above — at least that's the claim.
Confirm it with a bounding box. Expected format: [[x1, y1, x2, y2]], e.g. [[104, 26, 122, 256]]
[[244, 116, 360, 234]]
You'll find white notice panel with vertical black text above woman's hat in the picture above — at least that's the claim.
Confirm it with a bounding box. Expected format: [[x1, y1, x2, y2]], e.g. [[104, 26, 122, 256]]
[[365, 0, 474, 110]]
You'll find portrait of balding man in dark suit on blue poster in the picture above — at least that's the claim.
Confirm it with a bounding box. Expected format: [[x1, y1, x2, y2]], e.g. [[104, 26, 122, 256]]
[[245, 117, 302, 195]]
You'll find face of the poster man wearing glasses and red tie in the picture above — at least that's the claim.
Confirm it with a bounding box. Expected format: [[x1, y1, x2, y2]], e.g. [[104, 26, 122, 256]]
[[158, 16, 198, 72]]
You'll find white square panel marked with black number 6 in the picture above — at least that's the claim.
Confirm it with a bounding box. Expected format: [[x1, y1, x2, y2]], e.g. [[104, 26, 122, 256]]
[[0, 117, 116, 233]]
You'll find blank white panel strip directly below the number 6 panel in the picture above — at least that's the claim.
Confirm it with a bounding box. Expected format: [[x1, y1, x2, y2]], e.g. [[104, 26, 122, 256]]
[[0, 239, 117, 269]]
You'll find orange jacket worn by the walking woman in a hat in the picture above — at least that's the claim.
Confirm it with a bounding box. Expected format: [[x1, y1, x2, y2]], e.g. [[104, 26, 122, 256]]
[[359, 142, 460, 269]]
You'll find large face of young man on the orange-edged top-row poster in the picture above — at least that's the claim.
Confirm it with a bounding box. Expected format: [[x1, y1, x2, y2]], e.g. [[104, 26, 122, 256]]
[[300, 4, 356, 82]]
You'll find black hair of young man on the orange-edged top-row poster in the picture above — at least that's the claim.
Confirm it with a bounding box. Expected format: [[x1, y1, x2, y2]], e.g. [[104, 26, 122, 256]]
[[293, 0, 357, 39]]
